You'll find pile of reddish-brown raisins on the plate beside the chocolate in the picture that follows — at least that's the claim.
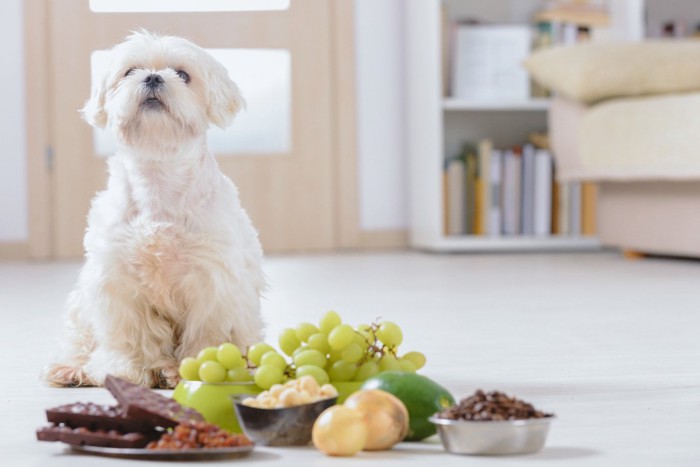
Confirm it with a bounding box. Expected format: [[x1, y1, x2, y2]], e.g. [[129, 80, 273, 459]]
[[146, 422, 253, 449]]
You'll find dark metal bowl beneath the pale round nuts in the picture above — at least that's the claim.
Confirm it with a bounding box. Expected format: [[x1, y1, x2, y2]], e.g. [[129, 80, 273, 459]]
[[231, 395, 338, 446]]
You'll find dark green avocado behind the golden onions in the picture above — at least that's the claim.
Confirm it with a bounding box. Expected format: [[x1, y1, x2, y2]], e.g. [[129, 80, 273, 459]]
[[362, 371, 455, 441]]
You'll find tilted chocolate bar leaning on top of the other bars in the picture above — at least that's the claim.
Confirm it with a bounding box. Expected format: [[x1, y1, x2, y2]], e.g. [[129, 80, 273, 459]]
[[105, 375, 204, 428]]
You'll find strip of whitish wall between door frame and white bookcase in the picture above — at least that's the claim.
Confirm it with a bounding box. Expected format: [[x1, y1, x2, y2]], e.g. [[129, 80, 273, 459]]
[[355, 0, 408, 230]]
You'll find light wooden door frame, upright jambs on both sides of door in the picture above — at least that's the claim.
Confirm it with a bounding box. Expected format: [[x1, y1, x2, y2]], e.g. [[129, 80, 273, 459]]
[[24, 0, 361, 259]]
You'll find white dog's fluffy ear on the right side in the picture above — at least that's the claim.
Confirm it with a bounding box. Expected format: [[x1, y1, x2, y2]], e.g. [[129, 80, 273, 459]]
[[207, 60, 245, 128]]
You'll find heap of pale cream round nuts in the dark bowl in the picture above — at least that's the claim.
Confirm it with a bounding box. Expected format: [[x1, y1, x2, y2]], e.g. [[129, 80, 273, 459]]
[[243, 376, 338, 409]]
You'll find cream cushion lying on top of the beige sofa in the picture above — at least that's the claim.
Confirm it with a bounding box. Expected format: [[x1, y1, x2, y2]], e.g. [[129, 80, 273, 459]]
[[524, 40, 700, 103]]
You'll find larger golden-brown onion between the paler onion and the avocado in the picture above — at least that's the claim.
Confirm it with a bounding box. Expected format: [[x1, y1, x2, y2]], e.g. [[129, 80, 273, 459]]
[[344, 389, 408, 451]]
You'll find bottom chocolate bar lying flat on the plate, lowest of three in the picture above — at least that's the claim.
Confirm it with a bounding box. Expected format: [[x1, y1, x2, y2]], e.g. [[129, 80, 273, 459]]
[[36, 425, 153, 448]]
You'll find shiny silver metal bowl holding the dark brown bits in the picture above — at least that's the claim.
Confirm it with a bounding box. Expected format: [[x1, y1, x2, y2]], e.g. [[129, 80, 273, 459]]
[[428, 415, 555, 456]]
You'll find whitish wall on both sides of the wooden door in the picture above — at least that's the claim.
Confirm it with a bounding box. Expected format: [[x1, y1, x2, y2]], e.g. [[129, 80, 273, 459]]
[[0, 0, 407, 242]]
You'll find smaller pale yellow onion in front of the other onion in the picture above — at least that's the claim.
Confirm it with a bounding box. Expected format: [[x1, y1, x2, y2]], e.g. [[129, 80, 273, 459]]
[[311, 405, 367, 456]]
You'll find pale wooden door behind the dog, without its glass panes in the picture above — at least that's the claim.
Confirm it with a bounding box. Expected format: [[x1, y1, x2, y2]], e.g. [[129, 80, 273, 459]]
[[48, 0, 353, 258]]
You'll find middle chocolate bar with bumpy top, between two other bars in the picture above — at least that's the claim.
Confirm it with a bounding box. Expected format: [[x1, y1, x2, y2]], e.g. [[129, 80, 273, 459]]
[[46, 402, 159, 433]]
